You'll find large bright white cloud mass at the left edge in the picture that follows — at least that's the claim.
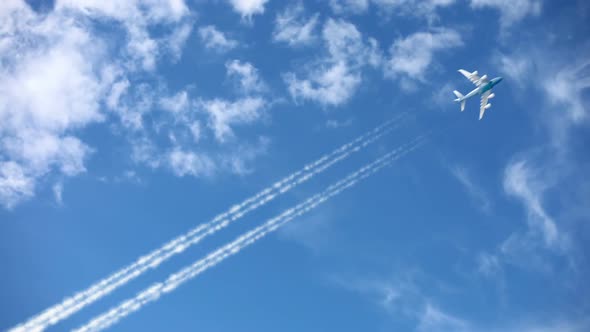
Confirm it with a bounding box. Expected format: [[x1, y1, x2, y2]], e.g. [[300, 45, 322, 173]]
[[0, 4, 105, 207]]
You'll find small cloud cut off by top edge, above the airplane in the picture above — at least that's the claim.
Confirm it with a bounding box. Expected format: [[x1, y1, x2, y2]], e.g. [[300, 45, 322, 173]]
[[471, 0, 541, 28]]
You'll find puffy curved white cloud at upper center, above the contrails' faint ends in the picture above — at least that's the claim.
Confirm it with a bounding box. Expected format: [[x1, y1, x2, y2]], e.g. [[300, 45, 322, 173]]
[[283, 19, 381, 106]]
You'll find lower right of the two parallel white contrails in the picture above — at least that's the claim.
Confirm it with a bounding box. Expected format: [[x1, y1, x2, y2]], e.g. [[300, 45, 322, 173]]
[[74, 136, 425, 332]]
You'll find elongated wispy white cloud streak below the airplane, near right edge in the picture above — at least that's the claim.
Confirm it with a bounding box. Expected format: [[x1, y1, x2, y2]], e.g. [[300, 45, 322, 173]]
[[504, 160, 562, 247]]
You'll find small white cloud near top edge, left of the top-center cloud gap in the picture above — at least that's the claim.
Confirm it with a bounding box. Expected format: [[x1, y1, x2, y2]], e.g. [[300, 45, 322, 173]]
[[273, 2, 319, 46]]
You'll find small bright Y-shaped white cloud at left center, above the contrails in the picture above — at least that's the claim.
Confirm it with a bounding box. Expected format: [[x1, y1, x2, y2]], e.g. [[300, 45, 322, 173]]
[[201, 97, 266, 143]]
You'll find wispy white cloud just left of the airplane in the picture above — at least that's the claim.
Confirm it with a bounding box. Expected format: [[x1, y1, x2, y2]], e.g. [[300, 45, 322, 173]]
[[385, 29, 463, 80]]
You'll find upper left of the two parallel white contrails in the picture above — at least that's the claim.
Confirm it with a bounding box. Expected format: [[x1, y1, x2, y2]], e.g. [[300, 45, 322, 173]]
[[10, 113, 406, 332]]
